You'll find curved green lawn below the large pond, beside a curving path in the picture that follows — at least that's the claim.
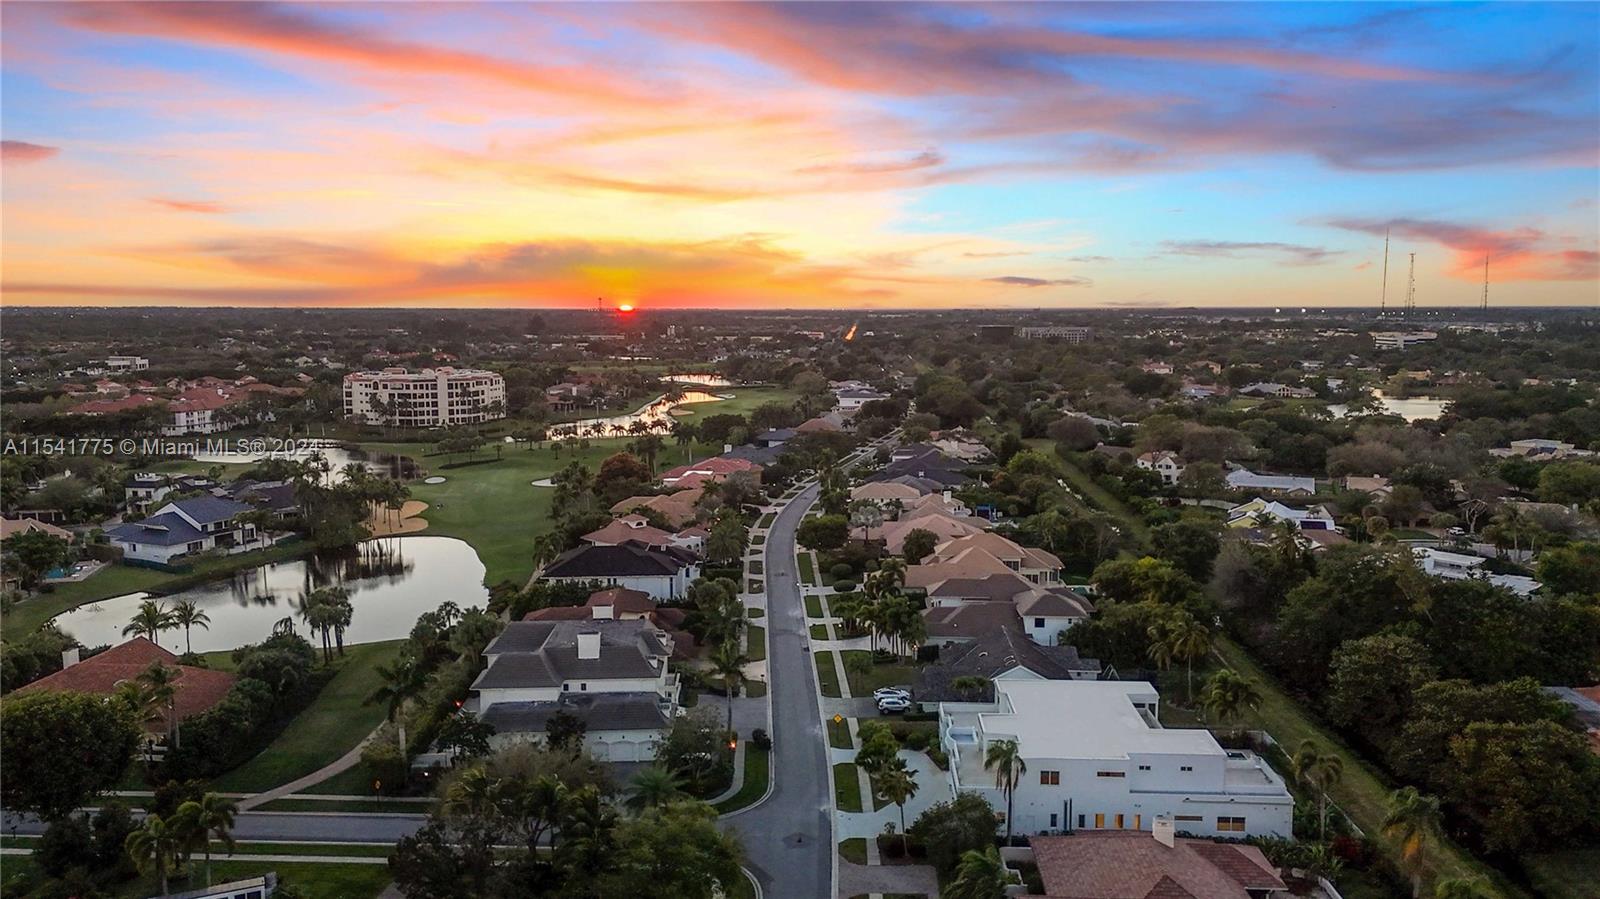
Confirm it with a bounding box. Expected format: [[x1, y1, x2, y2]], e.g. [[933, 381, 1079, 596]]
[[211, 640, 400, 792]]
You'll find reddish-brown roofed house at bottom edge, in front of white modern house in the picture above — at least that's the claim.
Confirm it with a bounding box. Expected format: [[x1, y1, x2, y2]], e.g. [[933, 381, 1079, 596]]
[[1006, 817, 1290, 899]]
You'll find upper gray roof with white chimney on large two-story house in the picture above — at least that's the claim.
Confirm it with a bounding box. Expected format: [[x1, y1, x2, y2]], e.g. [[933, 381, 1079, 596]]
[[472, 621, 670, 689]]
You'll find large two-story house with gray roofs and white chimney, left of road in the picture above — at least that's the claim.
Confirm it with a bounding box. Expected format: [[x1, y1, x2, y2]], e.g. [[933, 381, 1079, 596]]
[[467, 619, 678, 761]]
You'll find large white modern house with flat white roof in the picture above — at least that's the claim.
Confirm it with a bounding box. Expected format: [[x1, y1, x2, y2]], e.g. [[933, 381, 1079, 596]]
[[939, 678, 1294, 838]]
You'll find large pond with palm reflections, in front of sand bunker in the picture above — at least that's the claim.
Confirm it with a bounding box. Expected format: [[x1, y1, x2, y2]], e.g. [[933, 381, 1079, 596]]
[[54, 536, 490, 653]]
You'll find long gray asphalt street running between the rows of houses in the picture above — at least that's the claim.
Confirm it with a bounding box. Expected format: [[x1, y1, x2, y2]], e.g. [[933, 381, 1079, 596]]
[[725, 485, 835, 899]]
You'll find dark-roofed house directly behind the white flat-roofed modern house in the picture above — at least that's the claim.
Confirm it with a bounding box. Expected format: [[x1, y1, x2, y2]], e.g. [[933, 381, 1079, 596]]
[[912, 601, 1102, 710]]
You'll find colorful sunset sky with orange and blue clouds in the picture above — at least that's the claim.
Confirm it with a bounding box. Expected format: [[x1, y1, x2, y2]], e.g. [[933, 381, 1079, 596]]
[[0, 2, 1600, 309]]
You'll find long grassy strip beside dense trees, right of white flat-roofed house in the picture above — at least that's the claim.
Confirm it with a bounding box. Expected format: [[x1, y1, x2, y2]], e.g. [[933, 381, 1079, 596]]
[[1213, 635, 1526, 896]]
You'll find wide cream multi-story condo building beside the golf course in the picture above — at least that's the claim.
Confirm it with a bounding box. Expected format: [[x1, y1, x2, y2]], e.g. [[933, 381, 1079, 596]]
[[344, 366, 506, 427]]
